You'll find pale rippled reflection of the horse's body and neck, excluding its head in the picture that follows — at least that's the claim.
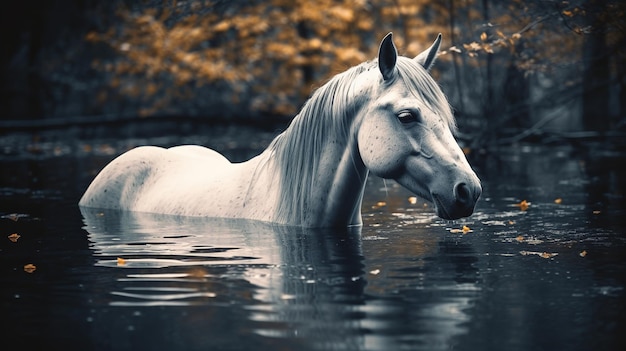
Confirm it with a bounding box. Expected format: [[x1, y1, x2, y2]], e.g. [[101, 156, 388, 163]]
[[81, 208, 365, 349]]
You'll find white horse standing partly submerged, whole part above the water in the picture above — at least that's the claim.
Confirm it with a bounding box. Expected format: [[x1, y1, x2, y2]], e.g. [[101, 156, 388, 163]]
[[79, 33, 481, 227]]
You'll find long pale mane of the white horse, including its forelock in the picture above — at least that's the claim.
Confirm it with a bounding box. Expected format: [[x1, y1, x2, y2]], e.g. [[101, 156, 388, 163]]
[[268, 57, 456, 224]]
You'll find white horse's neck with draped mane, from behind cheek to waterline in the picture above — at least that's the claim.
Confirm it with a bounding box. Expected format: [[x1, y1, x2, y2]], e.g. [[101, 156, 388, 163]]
[[271, 72, 367, 227]]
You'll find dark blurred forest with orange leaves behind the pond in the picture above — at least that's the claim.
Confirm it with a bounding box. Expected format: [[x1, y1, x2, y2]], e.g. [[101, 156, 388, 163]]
[[0, 0, 626, 145]]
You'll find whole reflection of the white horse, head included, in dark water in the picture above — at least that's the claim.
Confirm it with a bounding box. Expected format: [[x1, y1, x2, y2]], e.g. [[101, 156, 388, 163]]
[[82, 209, 472, 350]]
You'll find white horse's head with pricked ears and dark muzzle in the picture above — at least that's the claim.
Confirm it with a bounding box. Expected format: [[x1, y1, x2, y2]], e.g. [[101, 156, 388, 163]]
[[353, 33, 482, 219]]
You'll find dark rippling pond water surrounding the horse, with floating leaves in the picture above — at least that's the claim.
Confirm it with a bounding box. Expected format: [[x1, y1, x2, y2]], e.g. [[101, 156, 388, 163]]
[[0, 133, 626, 350]]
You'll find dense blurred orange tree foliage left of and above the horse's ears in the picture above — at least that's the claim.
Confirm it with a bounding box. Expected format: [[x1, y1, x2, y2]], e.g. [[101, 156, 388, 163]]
[[87, 0, 443, 116]]
